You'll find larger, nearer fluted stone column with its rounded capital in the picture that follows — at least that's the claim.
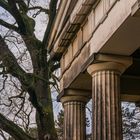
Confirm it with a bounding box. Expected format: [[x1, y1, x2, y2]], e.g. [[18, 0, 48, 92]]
[[87, 62, 128, 140]]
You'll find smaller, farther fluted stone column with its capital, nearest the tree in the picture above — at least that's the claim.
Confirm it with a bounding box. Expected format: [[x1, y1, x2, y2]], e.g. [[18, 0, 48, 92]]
[[61, 91, 89, 140]]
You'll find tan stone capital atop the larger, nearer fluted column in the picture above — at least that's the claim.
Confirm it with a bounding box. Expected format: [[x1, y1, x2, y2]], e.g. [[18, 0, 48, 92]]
[[87, 54, 132, 75]]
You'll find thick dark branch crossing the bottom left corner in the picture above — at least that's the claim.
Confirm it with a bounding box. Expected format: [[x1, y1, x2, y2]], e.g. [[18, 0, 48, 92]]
[[0, 113, 35, 140]]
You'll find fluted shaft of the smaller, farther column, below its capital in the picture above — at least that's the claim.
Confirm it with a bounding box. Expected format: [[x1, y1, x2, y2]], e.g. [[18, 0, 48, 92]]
[[64, 101, 86, 140]]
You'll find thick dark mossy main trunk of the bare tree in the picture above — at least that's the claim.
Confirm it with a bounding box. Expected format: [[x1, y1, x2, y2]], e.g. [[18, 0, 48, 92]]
[[23, 40, 57, 140]]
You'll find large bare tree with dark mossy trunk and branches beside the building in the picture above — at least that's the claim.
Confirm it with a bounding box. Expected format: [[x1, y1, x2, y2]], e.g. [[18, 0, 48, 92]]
[[0, 0, 59, 140]]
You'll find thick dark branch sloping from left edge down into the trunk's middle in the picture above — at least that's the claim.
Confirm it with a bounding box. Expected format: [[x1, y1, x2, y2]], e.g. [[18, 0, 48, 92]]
[[0, 36, 44, 123]]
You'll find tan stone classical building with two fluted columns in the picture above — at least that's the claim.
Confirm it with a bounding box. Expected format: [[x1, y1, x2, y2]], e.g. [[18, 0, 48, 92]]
[[49, 0, 140, 140]]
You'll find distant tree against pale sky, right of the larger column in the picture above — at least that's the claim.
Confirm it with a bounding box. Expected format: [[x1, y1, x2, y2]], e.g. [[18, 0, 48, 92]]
[[122, 102, 140, 140]]
